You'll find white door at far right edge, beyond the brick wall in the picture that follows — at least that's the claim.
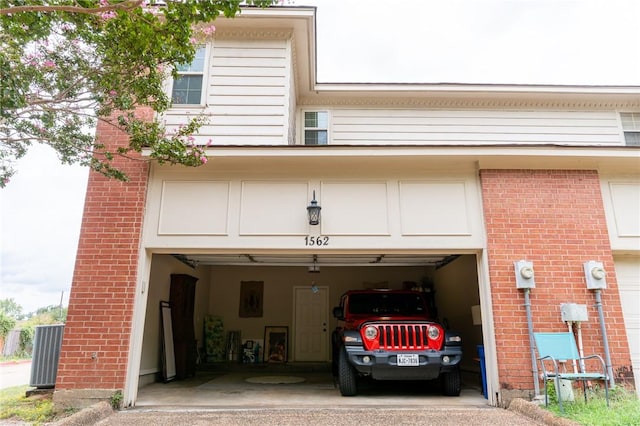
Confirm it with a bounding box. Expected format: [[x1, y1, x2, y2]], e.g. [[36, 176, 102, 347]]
[[615, 256, 640, 396]]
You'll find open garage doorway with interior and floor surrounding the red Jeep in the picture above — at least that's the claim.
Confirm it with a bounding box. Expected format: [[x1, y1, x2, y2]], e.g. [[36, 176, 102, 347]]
[[136, 254, 486, 405]]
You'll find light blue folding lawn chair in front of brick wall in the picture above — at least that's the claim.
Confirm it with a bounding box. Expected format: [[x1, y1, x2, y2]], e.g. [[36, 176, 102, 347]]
[[533, 331, 609, 413]]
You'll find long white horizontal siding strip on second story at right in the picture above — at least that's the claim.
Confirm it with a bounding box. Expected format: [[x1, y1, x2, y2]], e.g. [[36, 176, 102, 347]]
[[331, 109, 622, 145]]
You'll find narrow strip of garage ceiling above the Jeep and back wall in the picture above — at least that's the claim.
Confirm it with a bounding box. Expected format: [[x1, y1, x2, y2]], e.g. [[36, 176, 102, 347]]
[[174, 254, 459, 267]]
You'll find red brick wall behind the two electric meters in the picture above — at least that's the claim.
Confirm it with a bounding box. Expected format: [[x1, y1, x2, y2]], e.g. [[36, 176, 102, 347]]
[[480, 170, 631, 400]]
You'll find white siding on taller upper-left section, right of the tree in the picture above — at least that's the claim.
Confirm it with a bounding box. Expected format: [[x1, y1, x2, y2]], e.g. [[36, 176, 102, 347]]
[[165, 38, 291, 146]]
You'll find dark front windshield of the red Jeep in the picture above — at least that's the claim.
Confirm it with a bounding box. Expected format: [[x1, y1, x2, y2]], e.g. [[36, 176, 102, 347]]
[[348, 292, 427, 317]]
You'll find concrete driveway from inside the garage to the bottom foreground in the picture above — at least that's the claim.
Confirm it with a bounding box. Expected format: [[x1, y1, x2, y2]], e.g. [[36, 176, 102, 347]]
[[96, 365, 548, 426]]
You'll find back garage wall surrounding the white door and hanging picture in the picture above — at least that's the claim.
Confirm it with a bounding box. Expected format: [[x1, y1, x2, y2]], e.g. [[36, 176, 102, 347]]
[[208, 266, 430, 360]]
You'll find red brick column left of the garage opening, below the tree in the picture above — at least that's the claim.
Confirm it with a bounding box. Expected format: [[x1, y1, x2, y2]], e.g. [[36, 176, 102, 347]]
[[54, 111, 148, 397]]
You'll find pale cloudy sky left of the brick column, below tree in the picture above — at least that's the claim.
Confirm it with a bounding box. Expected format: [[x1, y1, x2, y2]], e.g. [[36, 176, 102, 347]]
[[0, 146, 88, 313]]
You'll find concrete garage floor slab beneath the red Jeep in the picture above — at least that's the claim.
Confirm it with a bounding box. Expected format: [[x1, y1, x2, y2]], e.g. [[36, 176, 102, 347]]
[[136, 365, 488, 409]]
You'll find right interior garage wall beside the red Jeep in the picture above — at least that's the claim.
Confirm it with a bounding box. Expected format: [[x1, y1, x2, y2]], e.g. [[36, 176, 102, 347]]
[[434, 255, 482, 371]]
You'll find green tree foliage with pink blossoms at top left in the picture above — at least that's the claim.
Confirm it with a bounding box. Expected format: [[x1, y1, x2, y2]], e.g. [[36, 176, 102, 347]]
[[0, 0, 275, 187]]
